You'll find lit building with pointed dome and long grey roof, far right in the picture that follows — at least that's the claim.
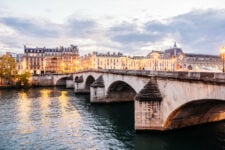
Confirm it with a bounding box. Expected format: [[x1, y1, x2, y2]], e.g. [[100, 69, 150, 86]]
[[148, 43, 222, 71]]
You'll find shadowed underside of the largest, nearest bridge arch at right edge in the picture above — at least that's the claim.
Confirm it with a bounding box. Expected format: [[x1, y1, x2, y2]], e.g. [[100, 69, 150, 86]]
[[164, 99, 225, 129]]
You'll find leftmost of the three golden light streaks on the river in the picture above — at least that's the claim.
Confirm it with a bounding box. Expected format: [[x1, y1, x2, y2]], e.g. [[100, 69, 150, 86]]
[[17, 92, 35, 134]]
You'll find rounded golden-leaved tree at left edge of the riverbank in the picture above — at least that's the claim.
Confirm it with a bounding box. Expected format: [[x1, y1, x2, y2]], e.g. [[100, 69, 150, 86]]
[[0, 54, 17, 84]]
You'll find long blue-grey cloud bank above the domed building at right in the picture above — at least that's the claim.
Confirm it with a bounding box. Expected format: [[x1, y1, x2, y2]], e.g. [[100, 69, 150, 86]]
[[110, 9, 225, 54]]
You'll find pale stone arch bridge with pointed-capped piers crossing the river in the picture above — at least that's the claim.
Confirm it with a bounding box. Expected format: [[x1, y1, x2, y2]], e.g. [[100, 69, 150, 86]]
[[73, 70, 225, 130]]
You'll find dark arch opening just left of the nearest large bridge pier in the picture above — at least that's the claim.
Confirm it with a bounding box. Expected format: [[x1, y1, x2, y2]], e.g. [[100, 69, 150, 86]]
[[106, 80, 137, 101]]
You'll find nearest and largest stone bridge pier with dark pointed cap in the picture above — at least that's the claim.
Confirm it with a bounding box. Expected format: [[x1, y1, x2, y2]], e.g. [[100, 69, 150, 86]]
[[134, 79, 163, 130]]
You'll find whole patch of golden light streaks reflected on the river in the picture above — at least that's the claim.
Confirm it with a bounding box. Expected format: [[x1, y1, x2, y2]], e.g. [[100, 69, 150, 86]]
[[17, 89, 85, 149]]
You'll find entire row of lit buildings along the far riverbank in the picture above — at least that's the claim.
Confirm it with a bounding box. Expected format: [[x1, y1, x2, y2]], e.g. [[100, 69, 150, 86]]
[[17, 43, 222, 74]]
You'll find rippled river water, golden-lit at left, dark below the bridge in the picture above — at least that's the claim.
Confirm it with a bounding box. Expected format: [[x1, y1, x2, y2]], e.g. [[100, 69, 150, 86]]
[[0, 88, 225, 150]]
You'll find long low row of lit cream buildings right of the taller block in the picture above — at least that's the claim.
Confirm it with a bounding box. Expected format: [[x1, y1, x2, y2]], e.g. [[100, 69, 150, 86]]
[[77, 43, 222, 72]]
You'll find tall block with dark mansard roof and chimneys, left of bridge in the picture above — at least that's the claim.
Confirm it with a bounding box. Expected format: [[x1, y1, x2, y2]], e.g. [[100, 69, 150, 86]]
[[20, 45, 79, 74]]
